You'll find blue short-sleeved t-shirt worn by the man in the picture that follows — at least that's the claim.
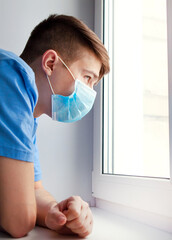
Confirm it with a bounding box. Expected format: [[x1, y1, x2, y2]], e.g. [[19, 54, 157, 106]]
[[0, 49, 41, 181]]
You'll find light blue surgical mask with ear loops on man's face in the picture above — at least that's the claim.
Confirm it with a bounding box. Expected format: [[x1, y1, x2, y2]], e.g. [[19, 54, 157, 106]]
[[47, 58, 96, 123]]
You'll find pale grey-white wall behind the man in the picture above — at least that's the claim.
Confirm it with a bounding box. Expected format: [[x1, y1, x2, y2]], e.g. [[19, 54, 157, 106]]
[[0, 0, 94, 201]]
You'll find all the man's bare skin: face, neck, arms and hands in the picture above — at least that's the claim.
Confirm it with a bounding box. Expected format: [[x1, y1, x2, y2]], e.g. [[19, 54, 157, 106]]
[[0, 48, 101, 238]]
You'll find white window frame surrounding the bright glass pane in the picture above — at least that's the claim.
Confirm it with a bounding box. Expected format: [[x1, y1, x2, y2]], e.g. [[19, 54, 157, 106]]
[[92, 0, 172, 232]]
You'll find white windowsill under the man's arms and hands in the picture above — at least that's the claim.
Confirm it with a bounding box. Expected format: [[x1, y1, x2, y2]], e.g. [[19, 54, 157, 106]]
[[0, 208, 172, 240]]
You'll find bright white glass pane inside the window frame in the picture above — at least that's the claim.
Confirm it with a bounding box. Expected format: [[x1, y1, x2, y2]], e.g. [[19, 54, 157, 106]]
[[103, 0, 170, 178]]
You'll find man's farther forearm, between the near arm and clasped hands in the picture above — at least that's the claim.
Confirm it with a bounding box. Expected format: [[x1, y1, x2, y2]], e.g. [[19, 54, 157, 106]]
[[35, 186, 57, 227]]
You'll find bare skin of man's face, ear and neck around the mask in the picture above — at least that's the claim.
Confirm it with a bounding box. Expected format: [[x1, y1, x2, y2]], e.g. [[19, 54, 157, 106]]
[[31, 48, 101, 117]]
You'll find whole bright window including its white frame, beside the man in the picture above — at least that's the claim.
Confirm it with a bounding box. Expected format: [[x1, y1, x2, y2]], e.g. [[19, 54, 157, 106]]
[[92, 0, 172, 231]]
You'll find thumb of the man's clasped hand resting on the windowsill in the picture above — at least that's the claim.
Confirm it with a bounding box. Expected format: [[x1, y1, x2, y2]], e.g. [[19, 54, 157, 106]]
[[45, 205, 67, 231]]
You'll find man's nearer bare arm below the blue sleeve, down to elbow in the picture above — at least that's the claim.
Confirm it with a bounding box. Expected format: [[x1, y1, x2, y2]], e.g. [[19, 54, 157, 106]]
[[0, 157, 36, 237]]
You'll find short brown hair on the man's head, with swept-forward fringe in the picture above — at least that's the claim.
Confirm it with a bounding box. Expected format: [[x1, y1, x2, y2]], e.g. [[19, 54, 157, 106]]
[[21, 14, 109, 79]]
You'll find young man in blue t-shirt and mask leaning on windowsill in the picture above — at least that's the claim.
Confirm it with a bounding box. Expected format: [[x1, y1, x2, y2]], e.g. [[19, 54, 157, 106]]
[[0, 15, 109, 237]]
